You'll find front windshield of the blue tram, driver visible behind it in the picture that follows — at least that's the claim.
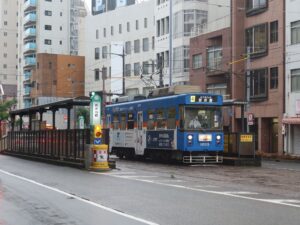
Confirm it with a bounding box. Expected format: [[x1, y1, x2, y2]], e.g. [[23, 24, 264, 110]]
[[184, 106, 222, 130]]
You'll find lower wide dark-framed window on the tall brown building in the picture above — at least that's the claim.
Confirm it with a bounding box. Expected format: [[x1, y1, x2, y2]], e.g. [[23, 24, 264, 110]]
[[250, 68, 268, 101]]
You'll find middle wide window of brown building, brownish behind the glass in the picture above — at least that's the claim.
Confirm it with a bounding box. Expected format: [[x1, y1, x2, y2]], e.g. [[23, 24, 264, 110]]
[[246, 23, 268, 58]]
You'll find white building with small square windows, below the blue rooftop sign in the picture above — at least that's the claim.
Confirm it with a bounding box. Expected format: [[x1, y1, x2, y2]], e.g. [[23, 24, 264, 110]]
[[82, 0, 158, 98]]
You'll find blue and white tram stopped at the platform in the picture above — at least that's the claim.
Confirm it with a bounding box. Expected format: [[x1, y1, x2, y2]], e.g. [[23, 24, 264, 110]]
[[105, 93, 224, 163]]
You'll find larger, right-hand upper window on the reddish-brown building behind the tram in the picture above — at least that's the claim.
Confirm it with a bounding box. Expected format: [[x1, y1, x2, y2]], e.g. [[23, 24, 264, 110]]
[[207, 46, 222, 71]]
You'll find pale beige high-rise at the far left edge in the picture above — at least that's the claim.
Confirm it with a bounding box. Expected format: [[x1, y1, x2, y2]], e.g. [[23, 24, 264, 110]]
[[0, 0, 18, 88]]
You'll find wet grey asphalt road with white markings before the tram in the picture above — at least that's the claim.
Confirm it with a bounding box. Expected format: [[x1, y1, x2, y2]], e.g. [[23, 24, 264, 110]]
[[0, 155, 300, 225]]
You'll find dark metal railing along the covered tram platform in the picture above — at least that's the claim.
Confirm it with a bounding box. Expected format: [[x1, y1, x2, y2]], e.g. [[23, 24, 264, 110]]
[[6, 129, 90, 163]]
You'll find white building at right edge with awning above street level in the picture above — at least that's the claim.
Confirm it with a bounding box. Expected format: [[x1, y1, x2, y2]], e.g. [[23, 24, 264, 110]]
[[282, 0, 300, 155]]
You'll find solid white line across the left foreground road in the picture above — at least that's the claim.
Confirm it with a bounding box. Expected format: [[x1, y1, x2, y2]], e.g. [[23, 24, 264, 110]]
[[0, 169, 158, 225]]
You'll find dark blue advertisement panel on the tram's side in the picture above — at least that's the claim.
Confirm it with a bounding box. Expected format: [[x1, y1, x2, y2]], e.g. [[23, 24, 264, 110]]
[[146, 130, 175, 149]]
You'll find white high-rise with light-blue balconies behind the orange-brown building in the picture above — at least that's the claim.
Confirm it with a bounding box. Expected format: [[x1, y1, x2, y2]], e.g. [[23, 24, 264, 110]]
[[18, 0, 85, 108]]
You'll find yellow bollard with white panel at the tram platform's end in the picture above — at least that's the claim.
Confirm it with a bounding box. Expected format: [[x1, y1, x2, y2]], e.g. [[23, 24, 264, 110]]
[[90, 144, 110, 172]]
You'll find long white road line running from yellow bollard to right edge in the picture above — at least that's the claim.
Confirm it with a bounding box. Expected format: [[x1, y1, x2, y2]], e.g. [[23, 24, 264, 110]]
[[92, 172, 300, 208]]
